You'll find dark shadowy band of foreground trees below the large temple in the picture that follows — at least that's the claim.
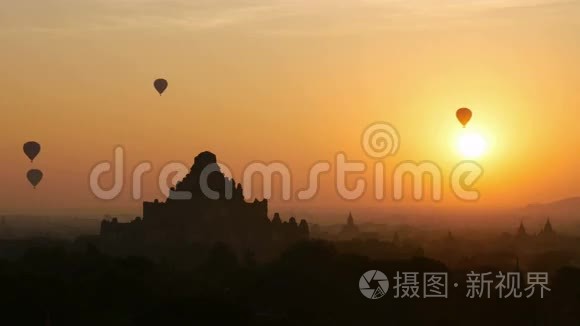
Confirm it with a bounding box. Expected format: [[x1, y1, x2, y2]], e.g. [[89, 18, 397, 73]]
[[0, 241, 580, 326]]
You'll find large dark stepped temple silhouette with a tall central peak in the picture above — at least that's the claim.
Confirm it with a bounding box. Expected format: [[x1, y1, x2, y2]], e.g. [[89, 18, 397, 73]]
[[99, 151, 309, 257]]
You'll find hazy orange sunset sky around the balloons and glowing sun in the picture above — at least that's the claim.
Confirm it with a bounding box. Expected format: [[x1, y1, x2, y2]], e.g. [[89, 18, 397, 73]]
[[0, 0, 580, 215]]
